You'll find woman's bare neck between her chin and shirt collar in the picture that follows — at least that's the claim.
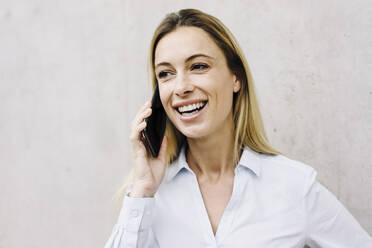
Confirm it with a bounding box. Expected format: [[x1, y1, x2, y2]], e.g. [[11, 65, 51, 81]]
[[186, 116, 235, 182]]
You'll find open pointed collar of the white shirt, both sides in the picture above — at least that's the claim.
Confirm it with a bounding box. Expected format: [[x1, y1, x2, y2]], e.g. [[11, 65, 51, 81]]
[[166, 145, 261, 182]]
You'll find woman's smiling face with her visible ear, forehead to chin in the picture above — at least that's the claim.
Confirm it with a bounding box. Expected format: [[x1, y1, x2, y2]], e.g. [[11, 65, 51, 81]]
[[155, 27, 240, 138]]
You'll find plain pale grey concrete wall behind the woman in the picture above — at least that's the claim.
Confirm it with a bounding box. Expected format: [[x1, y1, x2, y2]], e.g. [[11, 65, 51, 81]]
[[0, 0, 372, 248]]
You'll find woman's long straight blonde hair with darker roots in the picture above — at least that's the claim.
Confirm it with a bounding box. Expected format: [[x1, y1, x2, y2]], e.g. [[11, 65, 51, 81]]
[[112, 9, 280, 207]]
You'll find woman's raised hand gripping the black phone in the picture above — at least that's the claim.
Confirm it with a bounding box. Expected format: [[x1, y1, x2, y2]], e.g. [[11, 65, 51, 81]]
[[130, 101, 168, 197]]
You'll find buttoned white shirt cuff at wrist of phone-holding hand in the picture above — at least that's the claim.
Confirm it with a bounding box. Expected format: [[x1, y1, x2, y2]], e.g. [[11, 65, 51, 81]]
[[118, 185, 155, 232]]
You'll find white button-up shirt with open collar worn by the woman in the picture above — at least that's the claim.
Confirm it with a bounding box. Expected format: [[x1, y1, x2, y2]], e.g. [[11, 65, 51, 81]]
[[105, 144, 372, 248]]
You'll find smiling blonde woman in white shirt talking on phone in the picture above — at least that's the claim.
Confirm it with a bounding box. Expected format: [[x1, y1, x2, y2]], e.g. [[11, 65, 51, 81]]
[[105, 9, 372, 248]]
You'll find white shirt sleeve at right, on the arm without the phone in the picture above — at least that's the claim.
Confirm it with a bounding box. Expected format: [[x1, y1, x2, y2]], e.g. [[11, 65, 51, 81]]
[[304, 172, 372, 248]]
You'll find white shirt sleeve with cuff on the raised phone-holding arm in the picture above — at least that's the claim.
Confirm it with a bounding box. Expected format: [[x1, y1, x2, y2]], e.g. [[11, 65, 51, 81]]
[[105, 187, 159, 248]]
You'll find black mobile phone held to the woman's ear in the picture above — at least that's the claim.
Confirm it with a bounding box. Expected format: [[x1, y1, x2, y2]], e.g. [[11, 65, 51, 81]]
[[141, 86, 167, 158]]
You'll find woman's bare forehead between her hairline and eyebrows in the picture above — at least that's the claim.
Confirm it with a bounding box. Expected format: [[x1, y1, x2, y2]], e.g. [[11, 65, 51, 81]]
[[155, 27, 223, 64]]
